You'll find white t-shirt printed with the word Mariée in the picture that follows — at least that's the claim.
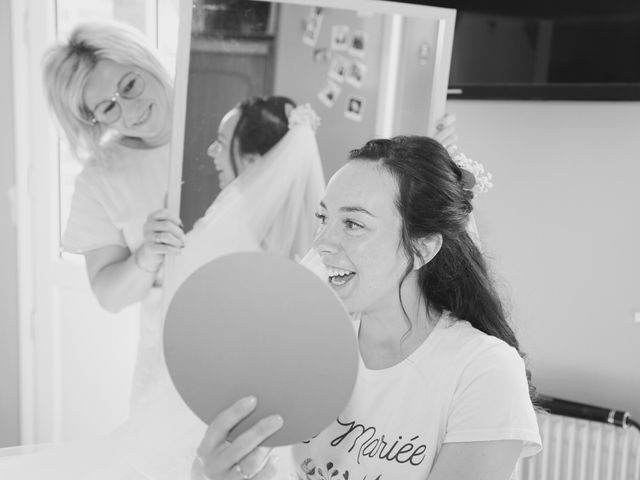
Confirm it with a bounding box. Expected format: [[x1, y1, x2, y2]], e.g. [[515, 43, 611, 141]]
[[289, 315, 541, 480]]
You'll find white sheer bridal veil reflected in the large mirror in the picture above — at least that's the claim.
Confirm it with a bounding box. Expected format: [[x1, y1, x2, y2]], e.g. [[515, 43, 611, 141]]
[[169, 113, 325, 295]]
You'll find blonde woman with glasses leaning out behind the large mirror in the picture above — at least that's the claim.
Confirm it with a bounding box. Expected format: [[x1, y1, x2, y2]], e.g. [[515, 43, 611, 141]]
[[44, 20, 184, 311]]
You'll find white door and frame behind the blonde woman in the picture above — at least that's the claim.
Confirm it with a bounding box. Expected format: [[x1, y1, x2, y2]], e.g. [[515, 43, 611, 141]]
[[12, 0, 178, 444]]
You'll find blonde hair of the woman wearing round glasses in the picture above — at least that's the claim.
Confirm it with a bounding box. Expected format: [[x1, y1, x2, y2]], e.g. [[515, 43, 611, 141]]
[[43, 22, 173, 161]]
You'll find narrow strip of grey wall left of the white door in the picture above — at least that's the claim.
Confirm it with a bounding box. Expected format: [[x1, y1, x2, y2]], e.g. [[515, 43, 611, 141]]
[[0, 1, 20, 447]]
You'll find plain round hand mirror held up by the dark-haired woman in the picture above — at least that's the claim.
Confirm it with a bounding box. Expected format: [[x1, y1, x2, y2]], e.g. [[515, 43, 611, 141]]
[[164, 253, 358, 446]]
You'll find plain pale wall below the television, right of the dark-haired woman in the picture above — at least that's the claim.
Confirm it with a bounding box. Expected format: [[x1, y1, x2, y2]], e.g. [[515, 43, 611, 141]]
[[447, 100, 640, 420]]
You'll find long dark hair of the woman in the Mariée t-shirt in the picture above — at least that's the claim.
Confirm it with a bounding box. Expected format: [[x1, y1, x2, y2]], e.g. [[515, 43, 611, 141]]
[[349, 136, 535, 399]]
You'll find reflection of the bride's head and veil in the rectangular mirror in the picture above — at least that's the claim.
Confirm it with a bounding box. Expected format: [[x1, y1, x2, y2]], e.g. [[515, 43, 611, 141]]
[[171, 96, 324, 285]]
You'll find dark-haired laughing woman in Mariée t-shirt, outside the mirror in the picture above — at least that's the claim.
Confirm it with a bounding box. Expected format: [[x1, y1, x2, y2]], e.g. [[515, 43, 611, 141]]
[[199, 136, 541, 480]]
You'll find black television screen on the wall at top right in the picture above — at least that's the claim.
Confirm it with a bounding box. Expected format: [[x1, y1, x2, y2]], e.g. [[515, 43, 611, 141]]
[[449, 10, 640, 100]]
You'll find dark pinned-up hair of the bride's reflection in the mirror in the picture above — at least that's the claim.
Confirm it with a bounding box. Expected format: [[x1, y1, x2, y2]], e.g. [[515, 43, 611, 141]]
[[230, 96, 296, 176]]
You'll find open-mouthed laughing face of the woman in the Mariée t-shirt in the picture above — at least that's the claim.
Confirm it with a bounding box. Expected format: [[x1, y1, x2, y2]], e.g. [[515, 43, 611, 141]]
[[314, 160, 408, 313]]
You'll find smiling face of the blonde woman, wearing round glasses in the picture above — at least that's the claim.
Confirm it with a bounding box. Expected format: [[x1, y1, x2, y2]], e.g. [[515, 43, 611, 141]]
[[83, 60, 171, 144]]
